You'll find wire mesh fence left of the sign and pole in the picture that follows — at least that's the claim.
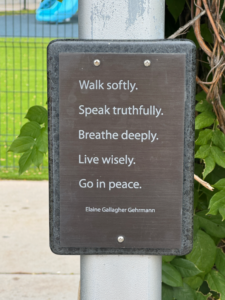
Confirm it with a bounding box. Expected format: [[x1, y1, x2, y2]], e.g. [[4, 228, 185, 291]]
[[0, 0, 78, 179]]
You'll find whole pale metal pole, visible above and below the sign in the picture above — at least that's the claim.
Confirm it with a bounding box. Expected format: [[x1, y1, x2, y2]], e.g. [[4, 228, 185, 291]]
[[78, 0, 165, 300]]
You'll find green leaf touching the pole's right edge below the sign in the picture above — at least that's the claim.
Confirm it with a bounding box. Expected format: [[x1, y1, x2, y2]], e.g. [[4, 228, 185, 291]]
[[162, 262, 182, 287]]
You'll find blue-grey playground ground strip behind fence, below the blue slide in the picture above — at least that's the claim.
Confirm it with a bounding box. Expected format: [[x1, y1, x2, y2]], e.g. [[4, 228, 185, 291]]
[[0, 14, 78, 38]]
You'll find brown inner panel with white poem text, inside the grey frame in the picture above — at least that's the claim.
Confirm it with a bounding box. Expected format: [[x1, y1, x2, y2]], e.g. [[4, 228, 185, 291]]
[[59, 53, 185, 248]]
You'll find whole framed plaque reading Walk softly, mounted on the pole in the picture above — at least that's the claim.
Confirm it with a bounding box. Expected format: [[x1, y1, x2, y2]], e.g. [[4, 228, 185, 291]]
[[48, 41, 195, 254]]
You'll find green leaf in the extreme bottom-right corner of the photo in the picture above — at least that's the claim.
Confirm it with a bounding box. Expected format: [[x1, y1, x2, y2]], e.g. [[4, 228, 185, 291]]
[[206, 270, 225, 300]]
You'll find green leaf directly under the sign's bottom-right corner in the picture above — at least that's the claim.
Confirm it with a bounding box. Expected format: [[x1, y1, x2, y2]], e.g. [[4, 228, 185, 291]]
[[171, 258, 201, 277]]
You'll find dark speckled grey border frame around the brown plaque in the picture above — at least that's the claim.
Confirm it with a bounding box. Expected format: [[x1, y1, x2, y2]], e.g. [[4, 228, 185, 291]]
[[48, 41, 195, 255]]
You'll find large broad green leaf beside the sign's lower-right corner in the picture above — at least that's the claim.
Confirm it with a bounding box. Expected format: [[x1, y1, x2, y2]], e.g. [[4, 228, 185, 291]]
[[186, 230, 216, 273]]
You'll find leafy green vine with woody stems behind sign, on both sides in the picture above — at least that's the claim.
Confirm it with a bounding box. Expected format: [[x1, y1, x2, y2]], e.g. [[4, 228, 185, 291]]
[[6, 0, 225, 300]]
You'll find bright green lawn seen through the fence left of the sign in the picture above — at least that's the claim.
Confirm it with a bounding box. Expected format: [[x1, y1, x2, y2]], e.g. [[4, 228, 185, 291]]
[[0, 37, 51, 180]]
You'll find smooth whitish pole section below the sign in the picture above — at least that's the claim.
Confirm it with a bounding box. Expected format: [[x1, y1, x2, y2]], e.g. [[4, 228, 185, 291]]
[[81, 255, 162, 300]]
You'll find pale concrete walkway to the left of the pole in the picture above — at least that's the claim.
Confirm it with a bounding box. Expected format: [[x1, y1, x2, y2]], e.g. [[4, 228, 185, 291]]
[[0, 180, 80, 300]]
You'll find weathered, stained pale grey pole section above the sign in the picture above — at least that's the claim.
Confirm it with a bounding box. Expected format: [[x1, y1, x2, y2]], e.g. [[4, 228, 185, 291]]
[[79, 0, 165, 40]]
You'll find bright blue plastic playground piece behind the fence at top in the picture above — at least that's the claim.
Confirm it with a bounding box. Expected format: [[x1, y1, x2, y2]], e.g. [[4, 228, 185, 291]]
[[36, 0, 78, 23]]
